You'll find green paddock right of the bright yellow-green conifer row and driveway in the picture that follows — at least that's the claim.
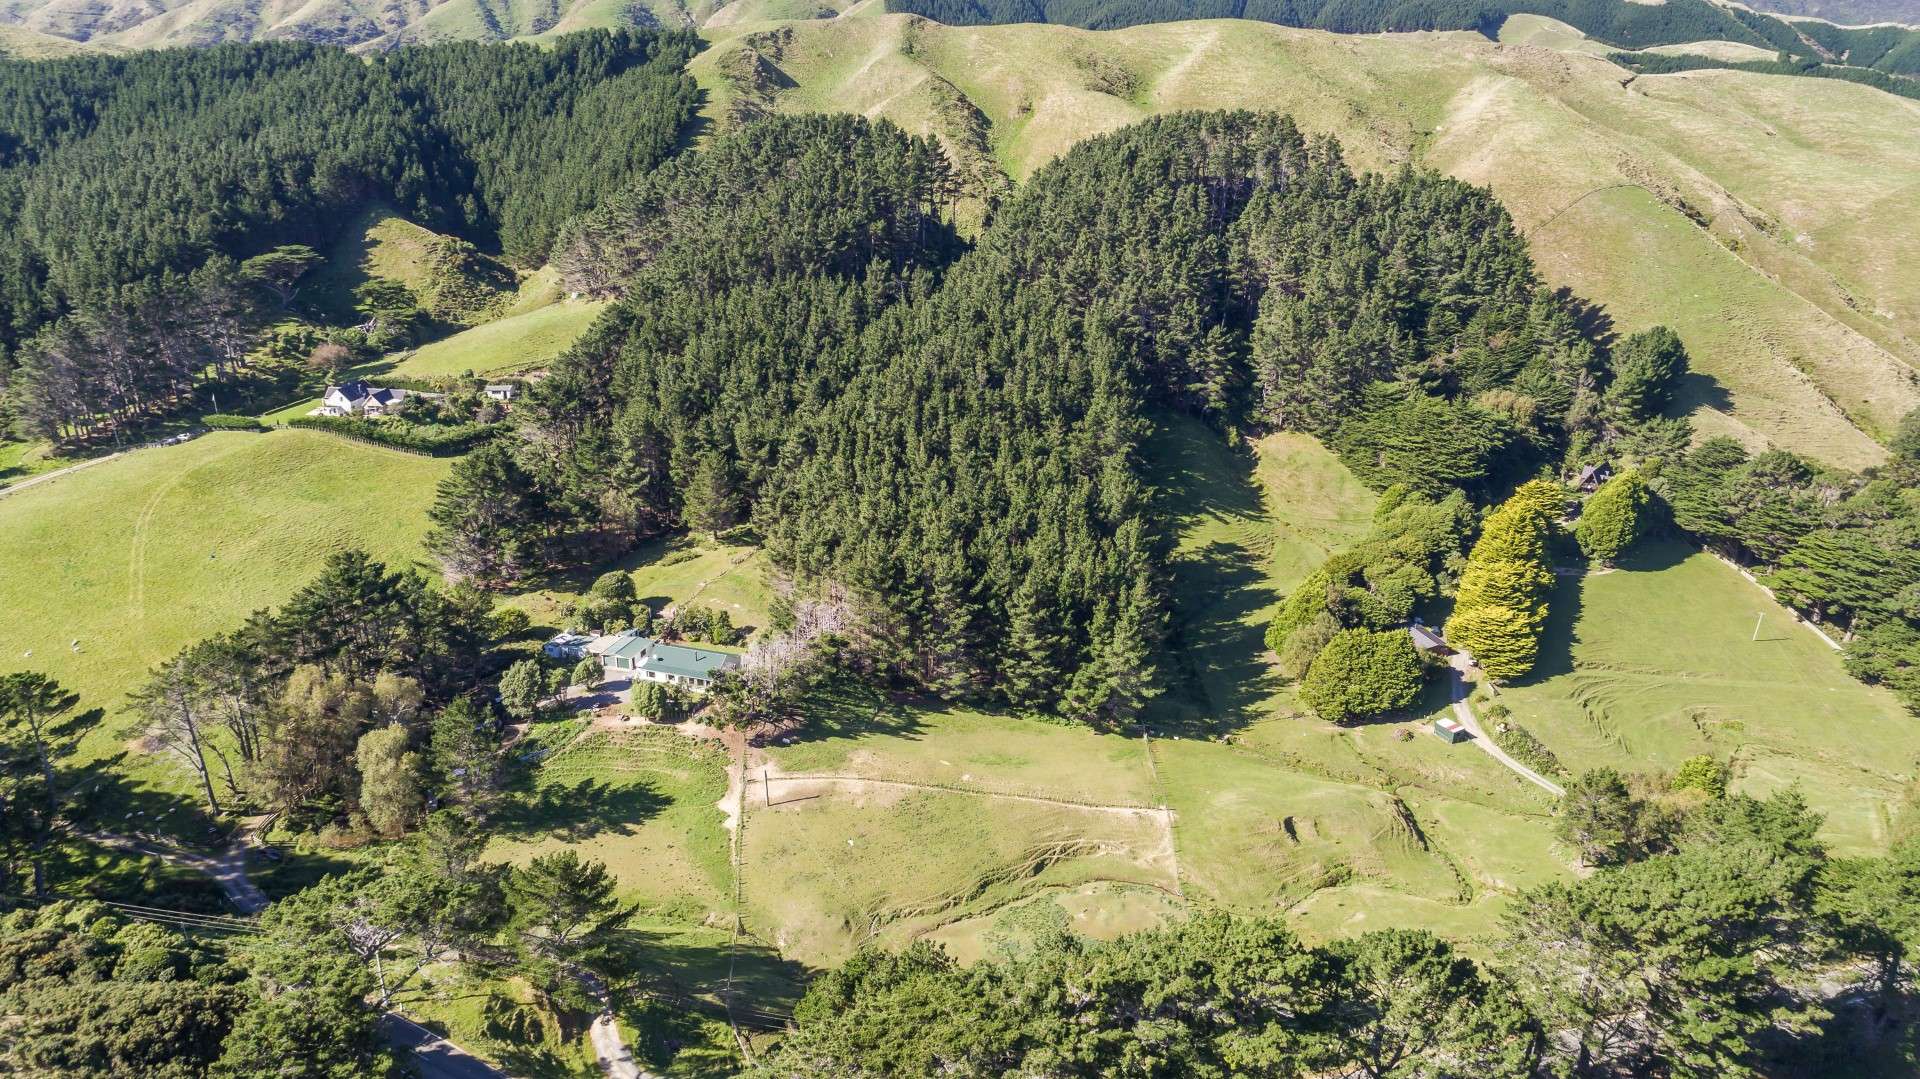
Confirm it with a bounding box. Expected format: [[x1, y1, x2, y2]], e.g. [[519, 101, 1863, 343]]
[[1500, 543, 1920, 852]]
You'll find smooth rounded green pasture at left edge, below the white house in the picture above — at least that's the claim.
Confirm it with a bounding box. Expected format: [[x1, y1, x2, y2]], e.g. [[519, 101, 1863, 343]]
[[0, 430, 447, 831]]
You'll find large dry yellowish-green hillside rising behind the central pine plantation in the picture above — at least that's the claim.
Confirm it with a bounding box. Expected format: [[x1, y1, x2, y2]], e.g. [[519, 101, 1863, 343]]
[[693, 15, 1920, 467]]
